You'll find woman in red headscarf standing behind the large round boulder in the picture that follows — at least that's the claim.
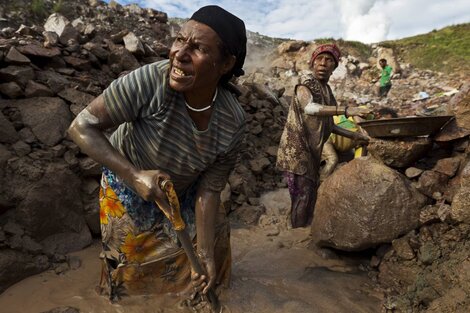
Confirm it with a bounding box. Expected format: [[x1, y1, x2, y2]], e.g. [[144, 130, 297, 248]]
[[277, 44, 370, 228]]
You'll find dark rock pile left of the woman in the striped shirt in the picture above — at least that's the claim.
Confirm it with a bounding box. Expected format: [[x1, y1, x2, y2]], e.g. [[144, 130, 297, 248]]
[[0, 1, 173, 290]]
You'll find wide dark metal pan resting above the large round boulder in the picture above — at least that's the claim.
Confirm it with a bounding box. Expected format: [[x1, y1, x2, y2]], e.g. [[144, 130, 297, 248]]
[[358, 115, 453, 138]]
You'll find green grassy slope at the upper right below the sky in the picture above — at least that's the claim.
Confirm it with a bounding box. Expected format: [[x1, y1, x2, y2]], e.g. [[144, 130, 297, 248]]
[[380, 23, 470, 74]]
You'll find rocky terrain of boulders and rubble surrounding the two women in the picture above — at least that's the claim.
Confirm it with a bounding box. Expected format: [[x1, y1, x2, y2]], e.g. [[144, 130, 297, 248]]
[[0, 0, 470, 313]]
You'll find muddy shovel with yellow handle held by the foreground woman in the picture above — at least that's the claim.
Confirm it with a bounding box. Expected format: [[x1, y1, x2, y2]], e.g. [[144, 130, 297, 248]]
[[157, 179, 222, 313]]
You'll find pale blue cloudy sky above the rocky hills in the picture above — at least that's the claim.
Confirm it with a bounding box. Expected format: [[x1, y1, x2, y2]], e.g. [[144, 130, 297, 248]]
[[107, 0, 470, 43]]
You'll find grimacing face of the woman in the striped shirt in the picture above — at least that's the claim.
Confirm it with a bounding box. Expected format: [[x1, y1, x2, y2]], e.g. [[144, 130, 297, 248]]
[[170, 20, 233, 94]]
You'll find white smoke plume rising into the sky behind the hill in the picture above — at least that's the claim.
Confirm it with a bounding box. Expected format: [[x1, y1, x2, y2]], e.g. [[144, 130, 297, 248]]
[[339, 0, 390, 43]]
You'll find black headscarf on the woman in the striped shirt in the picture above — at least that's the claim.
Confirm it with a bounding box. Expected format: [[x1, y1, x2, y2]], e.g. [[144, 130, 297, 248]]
[[190, 5, 246, 83]]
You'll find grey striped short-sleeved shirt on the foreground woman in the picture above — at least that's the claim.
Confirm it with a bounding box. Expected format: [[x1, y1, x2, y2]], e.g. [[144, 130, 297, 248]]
[[103, 60, 245, 193]]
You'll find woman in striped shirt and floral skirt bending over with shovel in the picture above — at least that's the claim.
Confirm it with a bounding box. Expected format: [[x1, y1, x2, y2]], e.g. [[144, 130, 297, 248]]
[[69, 6, 246, 308]]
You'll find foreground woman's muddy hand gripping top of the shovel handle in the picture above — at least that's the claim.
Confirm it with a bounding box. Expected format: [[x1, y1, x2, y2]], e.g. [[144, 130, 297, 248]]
[[132, 170, 170, 201]]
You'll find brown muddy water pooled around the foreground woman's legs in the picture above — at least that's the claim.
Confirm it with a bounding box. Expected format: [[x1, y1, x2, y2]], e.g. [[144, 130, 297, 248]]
[[0, 190, 381, 313]]
